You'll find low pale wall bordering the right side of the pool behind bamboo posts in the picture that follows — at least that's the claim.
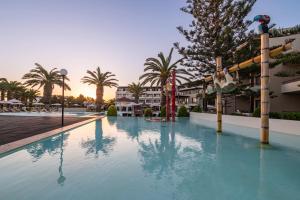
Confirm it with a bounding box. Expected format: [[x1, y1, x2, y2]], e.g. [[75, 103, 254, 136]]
[[190, 112, 300, 149]]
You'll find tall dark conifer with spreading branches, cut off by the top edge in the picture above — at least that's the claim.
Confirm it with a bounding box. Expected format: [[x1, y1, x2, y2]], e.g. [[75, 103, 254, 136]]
[[174, 0, 256, 109]]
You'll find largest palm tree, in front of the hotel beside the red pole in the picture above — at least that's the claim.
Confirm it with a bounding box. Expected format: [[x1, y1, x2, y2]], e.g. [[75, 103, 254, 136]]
[[140, 48, 192, 106]]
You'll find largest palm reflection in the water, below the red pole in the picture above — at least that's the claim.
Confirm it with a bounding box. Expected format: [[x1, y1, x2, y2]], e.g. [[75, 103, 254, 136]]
[[139, 124, 181, 178]]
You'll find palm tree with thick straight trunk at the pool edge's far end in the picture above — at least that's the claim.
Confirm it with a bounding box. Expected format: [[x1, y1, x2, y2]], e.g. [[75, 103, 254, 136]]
[[81, 67, 118, 112]]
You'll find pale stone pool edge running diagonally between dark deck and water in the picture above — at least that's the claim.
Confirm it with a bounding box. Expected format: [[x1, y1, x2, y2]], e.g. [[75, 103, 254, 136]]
[[0, 116, 104, 154]]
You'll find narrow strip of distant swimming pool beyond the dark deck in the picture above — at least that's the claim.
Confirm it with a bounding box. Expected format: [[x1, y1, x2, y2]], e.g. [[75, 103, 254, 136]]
[[0, 112, 96, 117]]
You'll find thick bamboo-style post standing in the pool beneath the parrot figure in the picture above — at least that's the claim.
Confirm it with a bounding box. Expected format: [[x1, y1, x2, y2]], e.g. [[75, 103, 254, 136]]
[[260, 33, 270, 144]]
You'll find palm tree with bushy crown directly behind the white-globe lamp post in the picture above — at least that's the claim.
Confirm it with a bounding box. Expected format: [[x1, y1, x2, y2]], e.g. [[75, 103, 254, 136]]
[[23, 63, 71, 104]]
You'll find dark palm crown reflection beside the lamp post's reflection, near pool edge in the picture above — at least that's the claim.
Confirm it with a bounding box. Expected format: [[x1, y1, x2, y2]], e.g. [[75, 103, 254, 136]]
[[26, 134, 69, 161]]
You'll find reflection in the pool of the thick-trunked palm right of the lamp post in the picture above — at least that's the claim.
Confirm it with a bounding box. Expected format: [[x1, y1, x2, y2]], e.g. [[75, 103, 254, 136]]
[[81, 120, 116, 158]]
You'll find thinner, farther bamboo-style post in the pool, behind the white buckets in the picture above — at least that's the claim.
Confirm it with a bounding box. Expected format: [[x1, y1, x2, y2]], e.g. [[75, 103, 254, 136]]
[[216, 56, 222, 133]]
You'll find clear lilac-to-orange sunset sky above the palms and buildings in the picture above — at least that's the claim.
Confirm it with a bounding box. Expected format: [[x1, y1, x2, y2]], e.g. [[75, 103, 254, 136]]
[[0, 0, 300, 99]]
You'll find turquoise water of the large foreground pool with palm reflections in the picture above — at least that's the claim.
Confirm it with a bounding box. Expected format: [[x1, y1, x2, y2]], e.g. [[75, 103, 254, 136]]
[[0, 117, 300, 200]]
